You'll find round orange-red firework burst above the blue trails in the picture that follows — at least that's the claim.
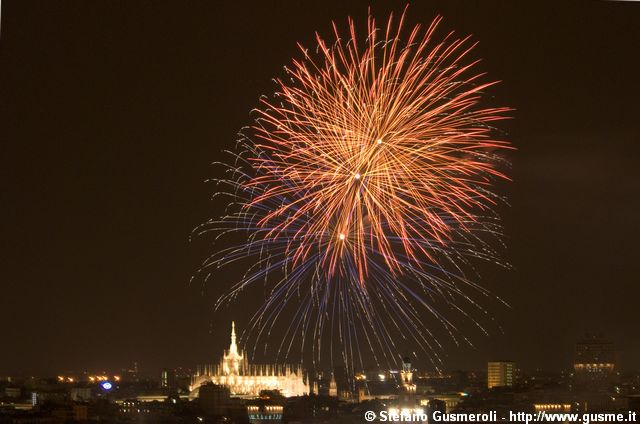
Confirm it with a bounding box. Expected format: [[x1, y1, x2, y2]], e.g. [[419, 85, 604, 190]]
[[242, 10, 509, 285]]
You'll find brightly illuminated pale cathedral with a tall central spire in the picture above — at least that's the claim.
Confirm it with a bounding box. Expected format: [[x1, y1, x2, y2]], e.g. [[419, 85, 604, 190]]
[[189, 322, 309, 398]]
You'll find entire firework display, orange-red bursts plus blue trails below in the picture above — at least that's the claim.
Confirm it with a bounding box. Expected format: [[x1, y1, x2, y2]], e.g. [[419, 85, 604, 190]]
[[195, 9, 510, 371]]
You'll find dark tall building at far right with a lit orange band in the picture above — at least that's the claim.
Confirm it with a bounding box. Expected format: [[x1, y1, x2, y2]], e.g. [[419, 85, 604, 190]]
[[573, 335, 616, 386]]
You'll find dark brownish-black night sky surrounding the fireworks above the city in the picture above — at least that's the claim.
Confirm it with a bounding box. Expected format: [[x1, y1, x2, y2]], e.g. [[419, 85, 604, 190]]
[[0, 0, 640, 375]]
